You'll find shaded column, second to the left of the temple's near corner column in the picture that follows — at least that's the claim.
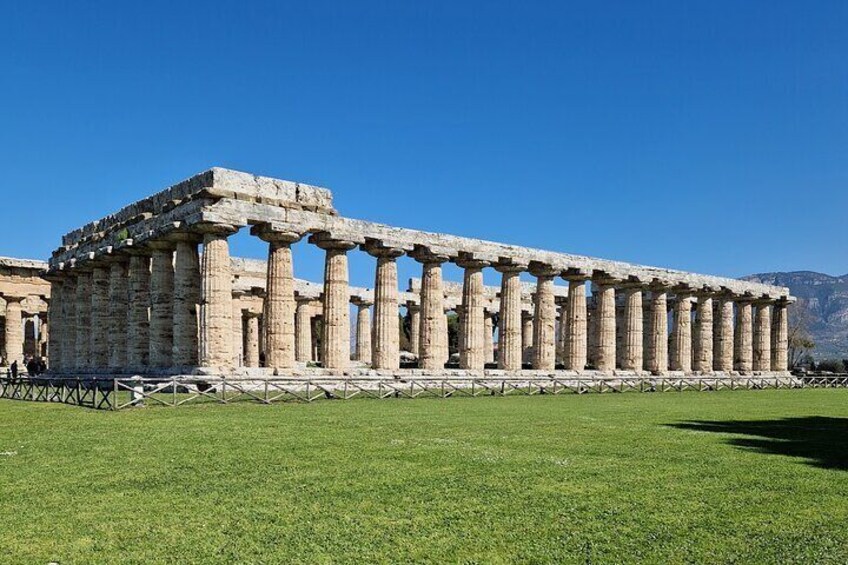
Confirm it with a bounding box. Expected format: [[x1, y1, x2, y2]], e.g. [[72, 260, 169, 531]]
[[149, 242, 174, 368]]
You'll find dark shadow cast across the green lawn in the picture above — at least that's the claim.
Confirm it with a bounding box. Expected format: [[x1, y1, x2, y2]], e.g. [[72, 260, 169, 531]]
[[669, 416, 848, 471]]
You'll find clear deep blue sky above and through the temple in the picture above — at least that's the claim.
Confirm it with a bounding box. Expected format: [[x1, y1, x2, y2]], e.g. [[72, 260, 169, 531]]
[[0, 0, 848, 286]]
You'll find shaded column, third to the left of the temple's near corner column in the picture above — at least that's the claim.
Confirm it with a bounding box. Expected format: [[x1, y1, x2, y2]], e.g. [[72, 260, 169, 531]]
[[127, 253, 150, 370]]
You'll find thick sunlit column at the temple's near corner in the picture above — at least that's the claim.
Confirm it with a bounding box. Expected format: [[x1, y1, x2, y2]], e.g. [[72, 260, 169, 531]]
[[200, 228, 234, 369]]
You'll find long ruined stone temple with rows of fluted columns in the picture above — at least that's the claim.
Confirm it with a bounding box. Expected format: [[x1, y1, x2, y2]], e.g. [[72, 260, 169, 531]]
[[28, 168, 793, 377]]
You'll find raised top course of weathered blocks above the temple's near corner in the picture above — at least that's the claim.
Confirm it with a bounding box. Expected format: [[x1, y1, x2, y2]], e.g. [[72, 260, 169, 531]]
[[62, 167, 335, 247]]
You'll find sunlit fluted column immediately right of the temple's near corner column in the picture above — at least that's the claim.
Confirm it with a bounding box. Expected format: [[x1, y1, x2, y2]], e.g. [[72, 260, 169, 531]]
[[251, 224, 303, 369]]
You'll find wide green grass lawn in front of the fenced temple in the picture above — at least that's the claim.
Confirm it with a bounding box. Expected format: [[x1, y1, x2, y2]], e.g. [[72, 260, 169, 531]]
[[0, 390, 848, 563]]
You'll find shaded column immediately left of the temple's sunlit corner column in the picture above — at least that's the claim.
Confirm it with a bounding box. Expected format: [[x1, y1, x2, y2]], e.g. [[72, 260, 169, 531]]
[[172, 233, 202, 368]]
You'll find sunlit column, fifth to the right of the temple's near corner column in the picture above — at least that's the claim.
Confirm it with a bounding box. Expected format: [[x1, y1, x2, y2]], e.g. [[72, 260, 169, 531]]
[[457, 258, 489, 371]]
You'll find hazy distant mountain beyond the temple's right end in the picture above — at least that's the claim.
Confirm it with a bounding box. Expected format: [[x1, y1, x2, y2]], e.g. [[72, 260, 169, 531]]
[[742, 271, 848, 360]]
